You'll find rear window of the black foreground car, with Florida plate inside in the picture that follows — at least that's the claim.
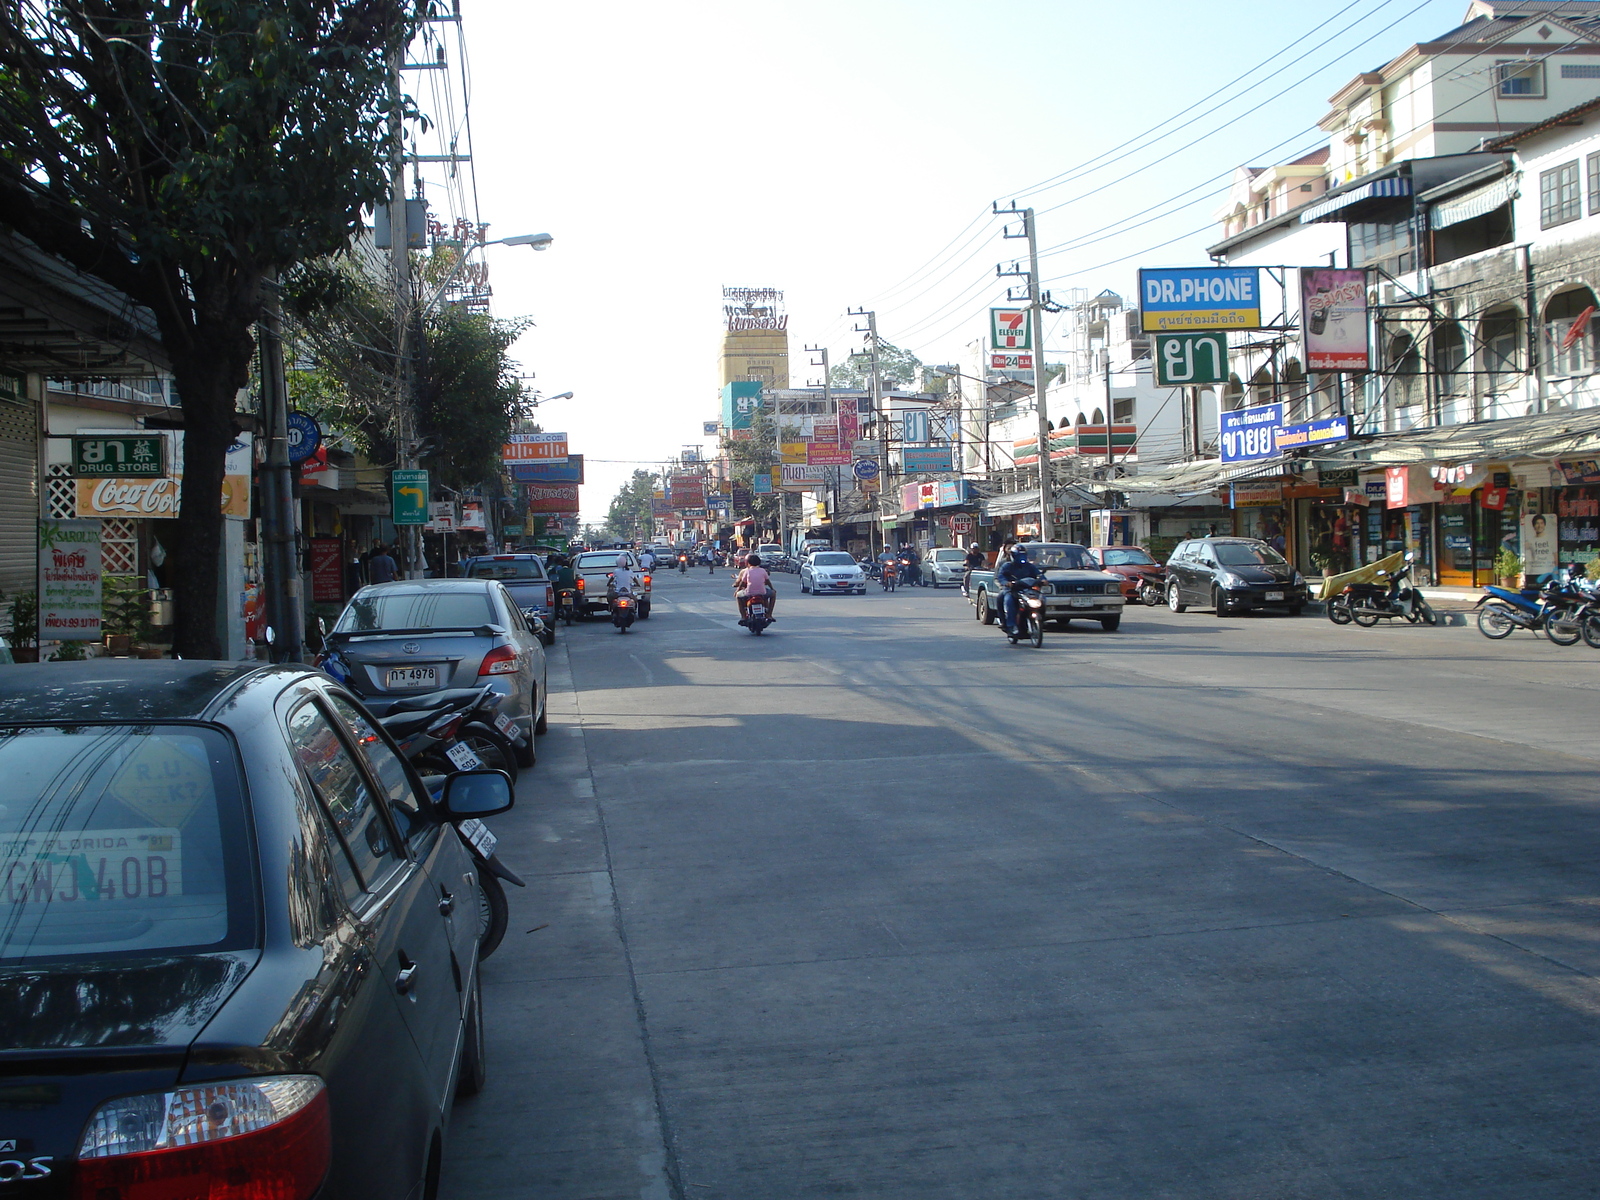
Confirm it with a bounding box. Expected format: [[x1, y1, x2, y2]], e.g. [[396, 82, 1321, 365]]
[[0, 725, 256, 962]]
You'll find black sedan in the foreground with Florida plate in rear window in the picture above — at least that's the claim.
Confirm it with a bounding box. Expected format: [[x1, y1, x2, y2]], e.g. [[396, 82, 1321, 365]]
[[0, 659, 510, 1200]]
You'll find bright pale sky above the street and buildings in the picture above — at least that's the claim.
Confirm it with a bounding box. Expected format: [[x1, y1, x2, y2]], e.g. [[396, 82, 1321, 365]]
[[410, 0, 1467, 520]]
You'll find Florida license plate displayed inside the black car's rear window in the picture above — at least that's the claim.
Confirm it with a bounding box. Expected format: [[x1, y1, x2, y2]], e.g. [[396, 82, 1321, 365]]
[[0, 829, 184, 906]]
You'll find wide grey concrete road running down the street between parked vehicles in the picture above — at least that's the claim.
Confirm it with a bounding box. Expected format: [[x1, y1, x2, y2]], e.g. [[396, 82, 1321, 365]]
[[443, 574, 1600, 1200]]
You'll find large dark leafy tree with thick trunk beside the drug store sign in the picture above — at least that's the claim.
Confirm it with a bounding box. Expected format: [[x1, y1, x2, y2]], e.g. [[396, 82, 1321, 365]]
[[0, 0, 429, 658]]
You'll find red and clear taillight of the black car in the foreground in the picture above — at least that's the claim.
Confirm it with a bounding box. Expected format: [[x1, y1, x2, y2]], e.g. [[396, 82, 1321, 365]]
[[72, 1075, 333, 1200]]
